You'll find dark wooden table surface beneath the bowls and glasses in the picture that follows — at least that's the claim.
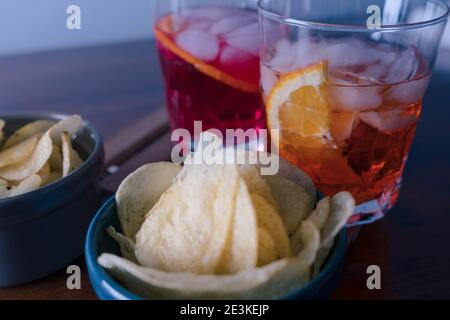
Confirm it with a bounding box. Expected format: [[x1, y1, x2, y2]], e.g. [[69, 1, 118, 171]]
[[0, 40, 450, 299]]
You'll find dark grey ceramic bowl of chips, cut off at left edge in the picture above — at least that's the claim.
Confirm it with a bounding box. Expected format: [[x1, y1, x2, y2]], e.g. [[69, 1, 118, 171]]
[[0, 113, 104, 287]]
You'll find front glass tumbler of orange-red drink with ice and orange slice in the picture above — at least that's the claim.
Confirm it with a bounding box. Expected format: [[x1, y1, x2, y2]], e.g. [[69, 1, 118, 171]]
[[259, 0, 449, 225]]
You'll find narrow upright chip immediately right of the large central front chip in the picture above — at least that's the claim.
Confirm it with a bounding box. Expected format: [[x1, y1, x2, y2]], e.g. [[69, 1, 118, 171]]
[[216, 181, 258, 274]]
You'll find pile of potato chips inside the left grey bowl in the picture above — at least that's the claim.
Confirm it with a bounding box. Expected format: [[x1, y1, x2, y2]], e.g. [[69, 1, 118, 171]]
[[0, 115, 83, 199]]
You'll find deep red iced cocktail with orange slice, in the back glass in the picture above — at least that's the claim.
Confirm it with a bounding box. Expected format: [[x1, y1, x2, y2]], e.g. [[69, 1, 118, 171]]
[[155, 7, 265, 139]]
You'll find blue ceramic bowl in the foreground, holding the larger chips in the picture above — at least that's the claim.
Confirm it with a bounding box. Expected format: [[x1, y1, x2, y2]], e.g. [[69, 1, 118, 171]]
[[85, 197, 346, 300]]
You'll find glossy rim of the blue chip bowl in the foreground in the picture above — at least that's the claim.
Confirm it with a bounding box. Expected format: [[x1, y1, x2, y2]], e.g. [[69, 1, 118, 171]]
[[85, 195, 347, 300]]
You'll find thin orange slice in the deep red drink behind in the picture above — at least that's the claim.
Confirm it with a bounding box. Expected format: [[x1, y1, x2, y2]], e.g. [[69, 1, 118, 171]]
[[154, 16, 259, 93]]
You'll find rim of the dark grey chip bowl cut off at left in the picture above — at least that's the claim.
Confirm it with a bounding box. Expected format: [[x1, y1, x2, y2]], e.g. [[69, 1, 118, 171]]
[[0, 112, 103, 205]]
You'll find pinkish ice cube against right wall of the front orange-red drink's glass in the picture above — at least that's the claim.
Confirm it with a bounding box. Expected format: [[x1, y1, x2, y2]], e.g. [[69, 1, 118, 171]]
[[387, 76, 430, 105]]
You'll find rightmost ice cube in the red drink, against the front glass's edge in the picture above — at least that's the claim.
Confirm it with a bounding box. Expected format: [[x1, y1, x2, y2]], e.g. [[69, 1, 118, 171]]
[[225, 23, 259, 56]]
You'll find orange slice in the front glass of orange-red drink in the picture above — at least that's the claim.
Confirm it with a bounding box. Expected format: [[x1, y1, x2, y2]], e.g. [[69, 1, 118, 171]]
[[267, 62, 331, 148]]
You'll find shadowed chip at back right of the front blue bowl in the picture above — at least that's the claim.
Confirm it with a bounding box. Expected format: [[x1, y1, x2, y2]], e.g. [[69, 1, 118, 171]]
[[263, 175, 313, 236]]
